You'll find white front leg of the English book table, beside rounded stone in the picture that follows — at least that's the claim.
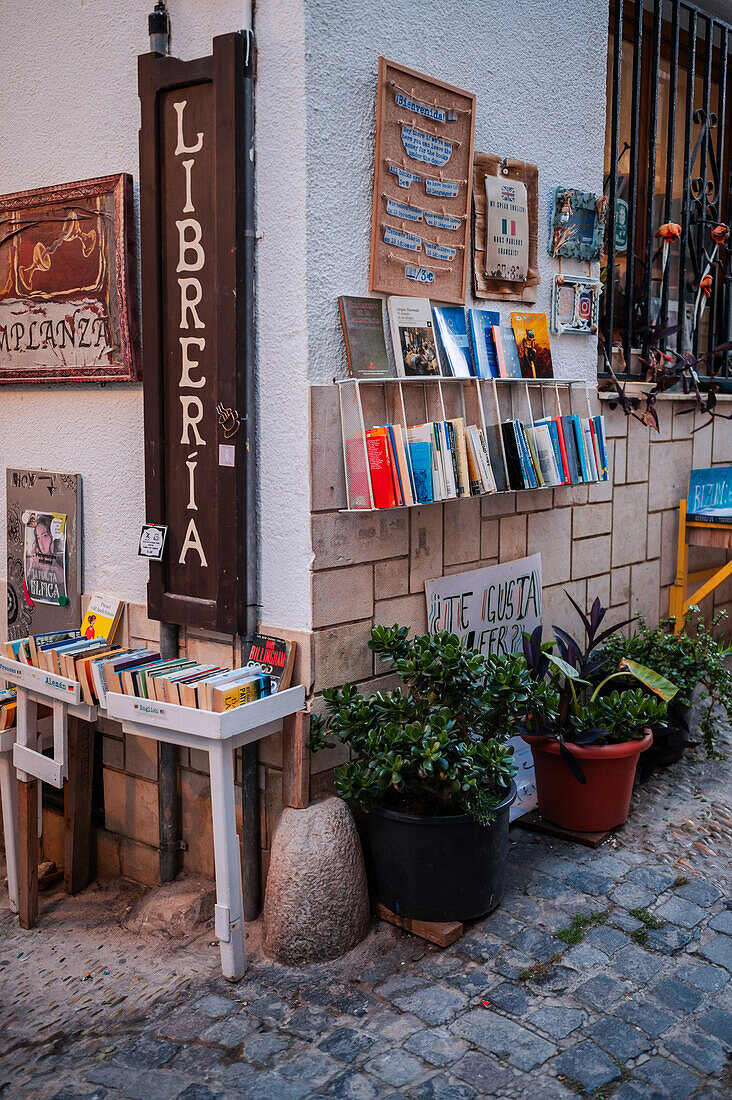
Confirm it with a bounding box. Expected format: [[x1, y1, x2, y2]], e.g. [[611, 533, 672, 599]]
[[208, 743, 247, 981]]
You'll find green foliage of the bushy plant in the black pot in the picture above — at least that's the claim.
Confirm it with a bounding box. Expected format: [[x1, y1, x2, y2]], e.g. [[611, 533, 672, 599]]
[[309, 626, 557, 824]]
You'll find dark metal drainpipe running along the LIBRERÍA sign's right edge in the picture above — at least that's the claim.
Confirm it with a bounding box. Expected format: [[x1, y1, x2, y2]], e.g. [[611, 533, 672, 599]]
[[241, 31, 262, 921]]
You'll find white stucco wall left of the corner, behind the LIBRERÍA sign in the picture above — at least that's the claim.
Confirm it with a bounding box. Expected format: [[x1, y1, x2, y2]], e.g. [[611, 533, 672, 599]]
[[0, 0, 309, 628]]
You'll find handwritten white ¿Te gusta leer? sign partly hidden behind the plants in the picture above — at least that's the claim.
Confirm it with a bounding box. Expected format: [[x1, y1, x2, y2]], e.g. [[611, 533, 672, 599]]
[[425, 553, 542, 821]]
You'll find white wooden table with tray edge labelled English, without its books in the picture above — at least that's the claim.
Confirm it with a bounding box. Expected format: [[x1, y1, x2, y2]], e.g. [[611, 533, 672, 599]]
[[106, 685, 305, 981]]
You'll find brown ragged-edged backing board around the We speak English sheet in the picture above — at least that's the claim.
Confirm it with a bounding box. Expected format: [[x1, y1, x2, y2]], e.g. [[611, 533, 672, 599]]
[[472, 153, 542, 303]]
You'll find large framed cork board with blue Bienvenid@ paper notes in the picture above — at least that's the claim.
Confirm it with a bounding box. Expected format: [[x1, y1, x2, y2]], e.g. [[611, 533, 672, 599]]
[[369, 57, 476, 305]]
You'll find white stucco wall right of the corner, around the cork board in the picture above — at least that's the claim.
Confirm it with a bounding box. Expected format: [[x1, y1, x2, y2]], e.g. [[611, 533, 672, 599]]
[[305, 0, 608, 383]]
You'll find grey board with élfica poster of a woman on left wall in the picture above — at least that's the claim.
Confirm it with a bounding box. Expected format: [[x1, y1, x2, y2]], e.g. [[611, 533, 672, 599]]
[[6, 470, 81, 640]]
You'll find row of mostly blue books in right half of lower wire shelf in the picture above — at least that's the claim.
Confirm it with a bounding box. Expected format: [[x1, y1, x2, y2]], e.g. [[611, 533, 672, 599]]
[[501, 414, 610, 490]]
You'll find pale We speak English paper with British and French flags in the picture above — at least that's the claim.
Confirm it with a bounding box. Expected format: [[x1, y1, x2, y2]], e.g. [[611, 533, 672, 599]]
[[485, 176, 528, 283]]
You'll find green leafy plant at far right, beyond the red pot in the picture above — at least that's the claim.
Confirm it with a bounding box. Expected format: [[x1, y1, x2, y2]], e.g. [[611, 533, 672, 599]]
[[601, 607, 732, 780]]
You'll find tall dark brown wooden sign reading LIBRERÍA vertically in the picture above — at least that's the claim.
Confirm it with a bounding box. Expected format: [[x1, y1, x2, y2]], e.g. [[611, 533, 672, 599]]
[[139, 33, 255, 634]]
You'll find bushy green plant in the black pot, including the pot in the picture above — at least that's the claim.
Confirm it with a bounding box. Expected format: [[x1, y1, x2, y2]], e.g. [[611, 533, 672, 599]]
[[310, 626, 556, 921]]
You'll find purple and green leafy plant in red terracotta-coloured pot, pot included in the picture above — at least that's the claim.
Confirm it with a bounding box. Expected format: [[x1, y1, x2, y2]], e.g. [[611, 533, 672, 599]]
[[524, 595, 676, 833]]
